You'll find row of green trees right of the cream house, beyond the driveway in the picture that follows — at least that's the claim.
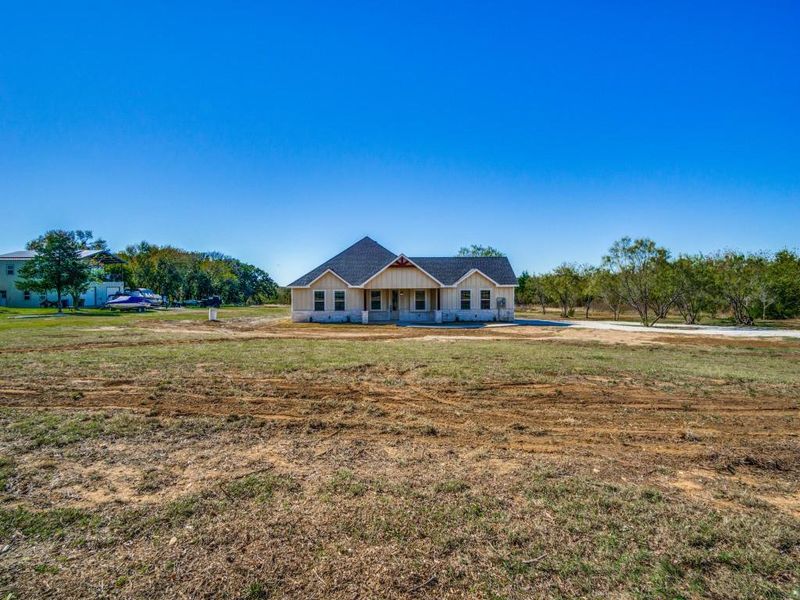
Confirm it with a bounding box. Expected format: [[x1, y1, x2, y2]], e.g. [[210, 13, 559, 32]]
[[516, 237, 800, 326]]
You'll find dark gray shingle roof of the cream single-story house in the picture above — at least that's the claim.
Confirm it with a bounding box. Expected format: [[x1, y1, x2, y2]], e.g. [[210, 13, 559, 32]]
[[289, 237, 517, 287]]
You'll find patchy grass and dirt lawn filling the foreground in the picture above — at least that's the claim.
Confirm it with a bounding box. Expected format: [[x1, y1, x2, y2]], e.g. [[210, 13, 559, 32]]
[[0, 307, 800, 600]]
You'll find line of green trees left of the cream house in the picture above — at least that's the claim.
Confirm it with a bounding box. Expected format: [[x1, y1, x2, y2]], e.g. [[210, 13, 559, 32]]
[[16, 230, 288, 311]]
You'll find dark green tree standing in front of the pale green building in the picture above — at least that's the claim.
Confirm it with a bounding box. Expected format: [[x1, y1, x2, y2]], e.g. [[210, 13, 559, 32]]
[[16, 230, 92, 313]]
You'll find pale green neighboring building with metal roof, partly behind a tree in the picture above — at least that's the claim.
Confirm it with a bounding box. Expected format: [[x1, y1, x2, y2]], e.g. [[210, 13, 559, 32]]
[[0, 250, 125, 308]]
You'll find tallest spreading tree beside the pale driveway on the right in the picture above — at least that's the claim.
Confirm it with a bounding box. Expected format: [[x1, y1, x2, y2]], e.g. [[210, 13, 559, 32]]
[[603, 237, 677, 327]]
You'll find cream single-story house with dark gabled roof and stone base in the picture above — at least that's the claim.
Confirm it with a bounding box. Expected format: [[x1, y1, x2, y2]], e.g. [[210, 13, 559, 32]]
[[288, 237, 517, 323]]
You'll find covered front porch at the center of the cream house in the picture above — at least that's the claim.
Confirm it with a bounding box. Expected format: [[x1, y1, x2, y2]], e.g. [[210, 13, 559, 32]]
[[361, 288, 442, 323]]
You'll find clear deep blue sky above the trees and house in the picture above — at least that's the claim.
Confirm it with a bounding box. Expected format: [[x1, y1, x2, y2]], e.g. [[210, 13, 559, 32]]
[[0, 1, 800, 283]]
